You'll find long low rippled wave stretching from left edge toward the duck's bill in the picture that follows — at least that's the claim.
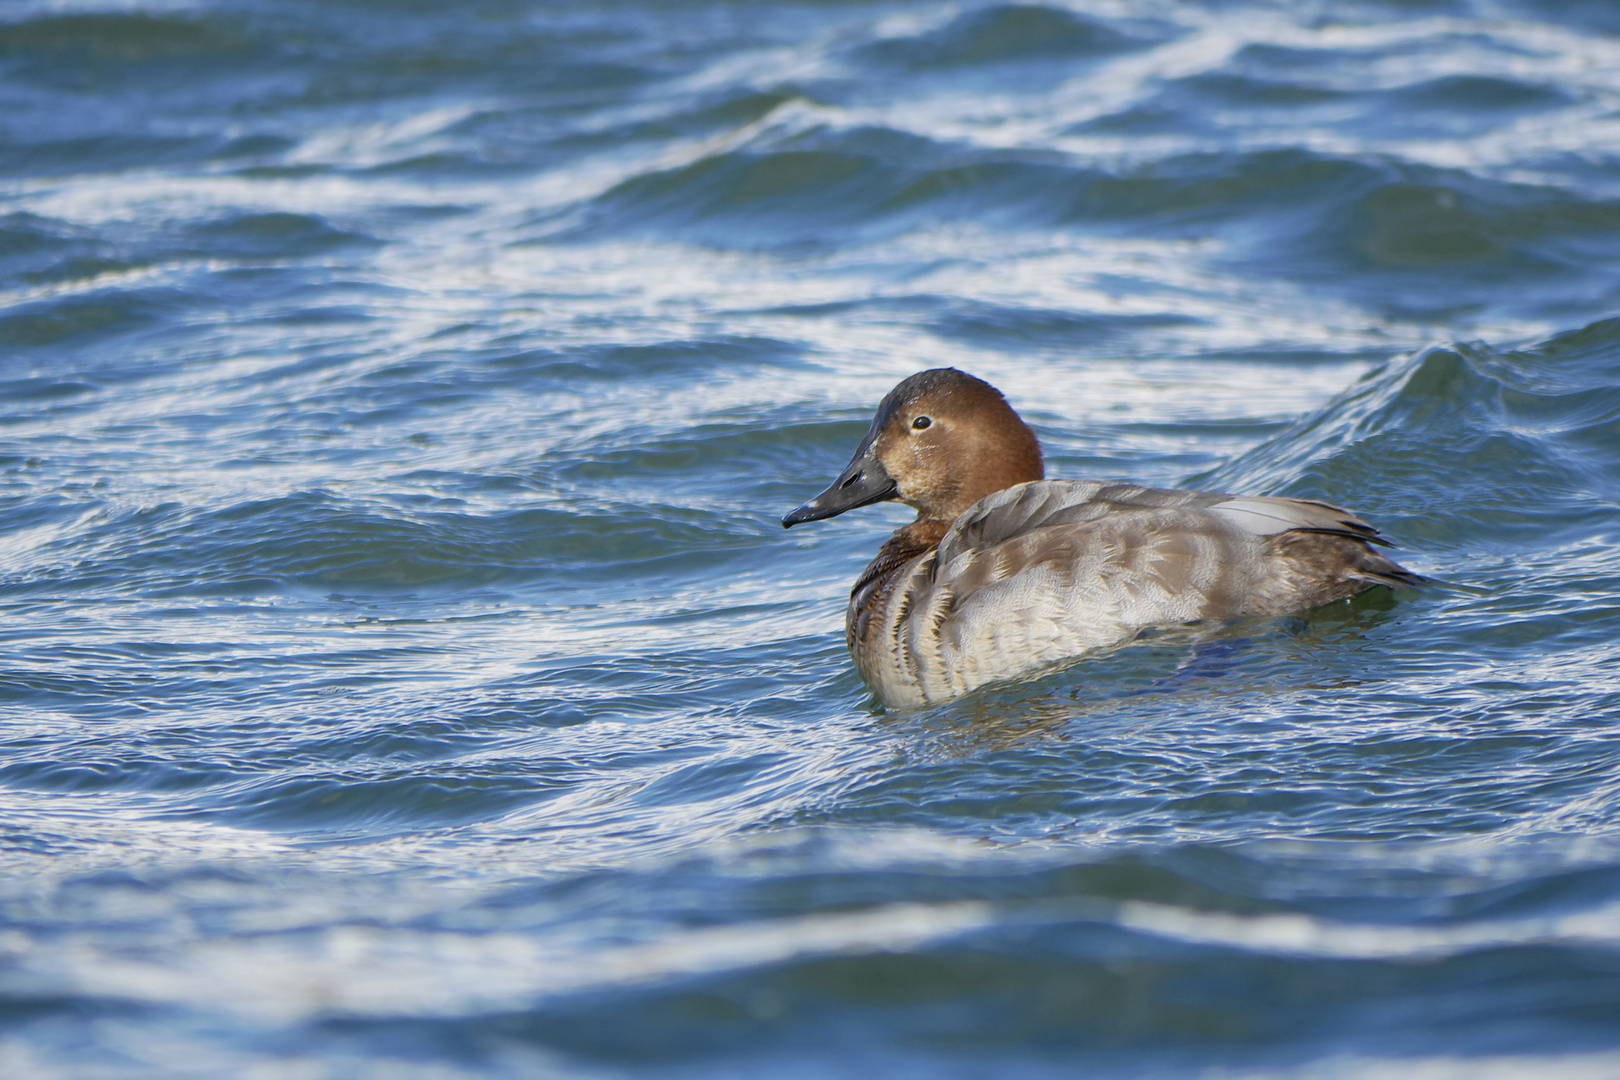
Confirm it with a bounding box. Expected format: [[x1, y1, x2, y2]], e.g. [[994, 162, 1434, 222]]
[[5, 489, 763, 596]]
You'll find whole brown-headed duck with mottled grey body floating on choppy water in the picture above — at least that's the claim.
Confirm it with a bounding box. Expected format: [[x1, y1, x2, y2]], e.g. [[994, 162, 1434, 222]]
[[782, 368, 1427, 709]]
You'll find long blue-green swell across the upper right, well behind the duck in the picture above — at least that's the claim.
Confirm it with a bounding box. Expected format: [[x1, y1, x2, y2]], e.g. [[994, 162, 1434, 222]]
[[563, 126, 1620, 319]]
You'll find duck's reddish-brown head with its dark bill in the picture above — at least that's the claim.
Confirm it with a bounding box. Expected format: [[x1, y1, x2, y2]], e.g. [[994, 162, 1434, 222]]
[[782, 368, 1045, 528]]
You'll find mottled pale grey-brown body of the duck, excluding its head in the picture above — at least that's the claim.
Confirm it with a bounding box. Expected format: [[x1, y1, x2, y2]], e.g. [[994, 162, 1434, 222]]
[[849, 481, 1419, 706]]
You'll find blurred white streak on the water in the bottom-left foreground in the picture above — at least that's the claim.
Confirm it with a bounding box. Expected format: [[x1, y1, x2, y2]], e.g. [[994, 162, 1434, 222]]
[[6, 902, 996, 1022]]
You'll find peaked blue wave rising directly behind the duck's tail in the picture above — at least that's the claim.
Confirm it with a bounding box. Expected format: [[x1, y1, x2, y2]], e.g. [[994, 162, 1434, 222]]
[[1194, 319, 1620, 551]]
